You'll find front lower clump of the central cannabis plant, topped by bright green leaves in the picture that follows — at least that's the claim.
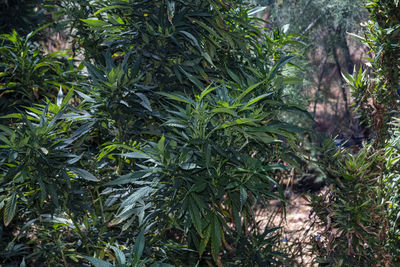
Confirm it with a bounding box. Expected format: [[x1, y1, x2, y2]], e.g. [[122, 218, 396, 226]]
[[103, 78, 304, 264]]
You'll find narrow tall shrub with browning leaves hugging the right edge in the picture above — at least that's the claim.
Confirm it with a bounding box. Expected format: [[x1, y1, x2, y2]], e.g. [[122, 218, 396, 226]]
[[344, 0, 400, 263]]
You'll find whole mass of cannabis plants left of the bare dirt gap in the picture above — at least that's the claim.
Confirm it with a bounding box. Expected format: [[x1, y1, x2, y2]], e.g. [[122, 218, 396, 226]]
[[0, 0, 306, 266]]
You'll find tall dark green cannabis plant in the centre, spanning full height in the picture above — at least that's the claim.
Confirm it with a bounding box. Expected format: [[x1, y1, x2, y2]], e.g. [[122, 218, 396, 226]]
[[66, 1, 304, 265]]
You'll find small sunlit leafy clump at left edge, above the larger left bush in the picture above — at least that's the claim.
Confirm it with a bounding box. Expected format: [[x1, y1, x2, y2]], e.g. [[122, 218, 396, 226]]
[[0, 28, 79, 113]]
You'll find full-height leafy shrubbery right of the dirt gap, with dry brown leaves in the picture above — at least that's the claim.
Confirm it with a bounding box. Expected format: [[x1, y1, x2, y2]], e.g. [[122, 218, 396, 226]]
[[313, 1, 400, 266]]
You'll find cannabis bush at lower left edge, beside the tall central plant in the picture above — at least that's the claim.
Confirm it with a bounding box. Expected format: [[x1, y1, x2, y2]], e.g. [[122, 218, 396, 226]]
[[0, 89, 99, 265]]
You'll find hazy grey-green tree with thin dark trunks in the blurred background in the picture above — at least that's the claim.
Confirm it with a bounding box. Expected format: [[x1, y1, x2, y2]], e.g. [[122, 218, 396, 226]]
[[253, 0, 368, 135]]
